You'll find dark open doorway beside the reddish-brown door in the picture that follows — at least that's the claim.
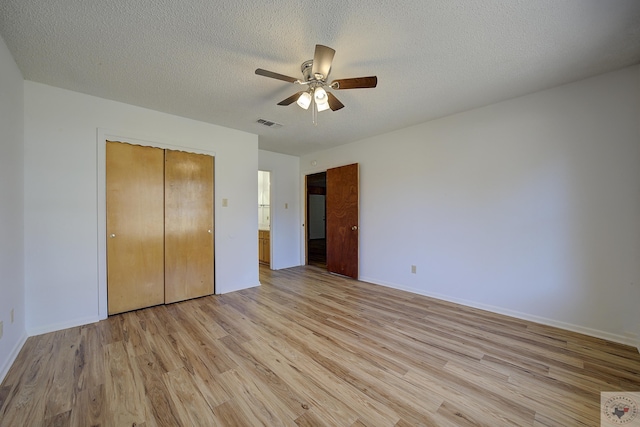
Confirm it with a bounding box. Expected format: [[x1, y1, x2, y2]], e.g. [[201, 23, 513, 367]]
[[307, 172, 327, 268]]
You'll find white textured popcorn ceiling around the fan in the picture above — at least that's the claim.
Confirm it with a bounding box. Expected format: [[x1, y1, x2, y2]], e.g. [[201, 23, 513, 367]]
[[0, 0, 640, 155]]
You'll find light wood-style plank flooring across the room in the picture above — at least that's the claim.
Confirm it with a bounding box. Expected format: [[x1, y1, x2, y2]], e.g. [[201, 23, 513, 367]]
[[0, 267, 640, 427]]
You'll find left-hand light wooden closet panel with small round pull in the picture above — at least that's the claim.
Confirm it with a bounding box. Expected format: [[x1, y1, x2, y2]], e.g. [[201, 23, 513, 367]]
[[106, 141, 164, 314]]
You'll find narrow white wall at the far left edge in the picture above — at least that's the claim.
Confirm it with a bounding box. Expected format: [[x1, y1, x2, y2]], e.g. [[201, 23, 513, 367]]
[[0, 33, 27, 382]]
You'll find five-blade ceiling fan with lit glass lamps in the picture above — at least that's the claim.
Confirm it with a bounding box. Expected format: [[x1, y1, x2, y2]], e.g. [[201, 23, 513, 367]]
[[256, 44, 378, 124]]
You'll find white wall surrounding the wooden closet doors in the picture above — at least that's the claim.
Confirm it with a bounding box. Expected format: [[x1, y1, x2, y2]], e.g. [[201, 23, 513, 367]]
[[24, 81, 259, 335]]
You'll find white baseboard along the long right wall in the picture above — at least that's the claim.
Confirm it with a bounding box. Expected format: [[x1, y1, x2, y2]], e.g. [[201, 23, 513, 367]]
[[359, 277, 640, 352]]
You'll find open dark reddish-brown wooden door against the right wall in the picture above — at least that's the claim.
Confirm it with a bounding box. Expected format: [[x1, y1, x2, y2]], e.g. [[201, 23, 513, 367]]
[[326, 163, 359, 279]]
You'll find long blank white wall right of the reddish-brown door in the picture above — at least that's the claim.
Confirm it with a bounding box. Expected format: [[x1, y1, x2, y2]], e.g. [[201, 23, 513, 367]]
[[300, 66, 640, 343]]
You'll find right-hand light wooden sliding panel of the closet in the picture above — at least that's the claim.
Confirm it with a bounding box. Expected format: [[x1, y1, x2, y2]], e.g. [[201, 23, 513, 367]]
[[165, 150, 214, 303]]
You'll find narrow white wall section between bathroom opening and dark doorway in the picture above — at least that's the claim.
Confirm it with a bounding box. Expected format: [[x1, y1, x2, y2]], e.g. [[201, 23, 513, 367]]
[[255, 150, 302, 270]]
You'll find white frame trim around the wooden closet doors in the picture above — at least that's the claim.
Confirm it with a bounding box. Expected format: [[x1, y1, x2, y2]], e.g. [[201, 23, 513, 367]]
[[96, 128, 219, 319]]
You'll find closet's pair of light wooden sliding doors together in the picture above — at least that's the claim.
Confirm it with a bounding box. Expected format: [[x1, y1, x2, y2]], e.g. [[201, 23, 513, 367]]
[[106, 141, 214, 314]]
